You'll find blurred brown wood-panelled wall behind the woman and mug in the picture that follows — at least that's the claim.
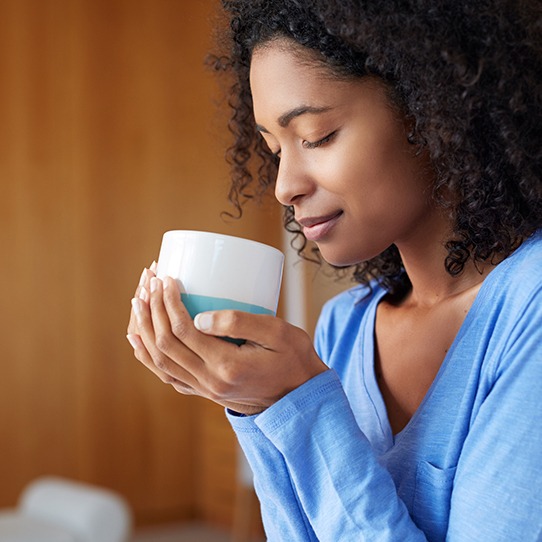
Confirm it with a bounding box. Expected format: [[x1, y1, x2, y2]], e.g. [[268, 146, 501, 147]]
[[0, 0, 348, 534]]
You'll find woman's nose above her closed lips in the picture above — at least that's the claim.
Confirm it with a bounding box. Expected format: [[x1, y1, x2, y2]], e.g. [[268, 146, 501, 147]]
[[275, 152, 315, 206]]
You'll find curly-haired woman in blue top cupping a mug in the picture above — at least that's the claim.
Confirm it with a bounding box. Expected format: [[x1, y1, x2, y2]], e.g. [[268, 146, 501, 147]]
[[128, 0, 542, 542]]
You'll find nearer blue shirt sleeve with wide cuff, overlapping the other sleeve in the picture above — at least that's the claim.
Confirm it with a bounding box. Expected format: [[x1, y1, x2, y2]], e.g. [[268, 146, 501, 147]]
[[254, 370, 426, 542]]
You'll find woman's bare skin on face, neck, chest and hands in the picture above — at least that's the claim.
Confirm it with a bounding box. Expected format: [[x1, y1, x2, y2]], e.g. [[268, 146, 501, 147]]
[[128, 40, 490, 432]]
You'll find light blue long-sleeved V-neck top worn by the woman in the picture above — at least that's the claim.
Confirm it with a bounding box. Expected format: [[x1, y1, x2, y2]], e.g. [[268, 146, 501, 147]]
[[228, 234, 542, 542]]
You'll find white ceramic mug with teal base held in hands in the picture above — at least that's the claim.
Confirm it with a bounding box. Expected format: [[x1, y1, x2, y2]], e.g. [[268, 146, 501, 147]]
[[156, 230, 284, 318]]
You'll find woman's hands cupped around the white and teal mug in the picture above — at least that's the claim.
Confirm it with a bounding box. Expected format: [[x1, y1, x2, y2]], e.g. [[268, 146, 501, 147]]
[[128, 276, 327, 415]]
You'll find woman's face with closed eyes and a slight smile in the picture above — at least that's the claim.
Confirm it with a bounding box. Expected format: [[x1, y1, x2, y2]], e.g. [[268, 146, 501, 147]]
[[250, 40, 442, 266]]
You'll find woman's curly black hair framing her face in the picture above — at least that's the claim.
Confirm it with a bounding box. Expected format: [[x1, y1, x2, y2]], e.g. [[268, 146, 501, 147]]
[[209, 0, 542, 294]]
